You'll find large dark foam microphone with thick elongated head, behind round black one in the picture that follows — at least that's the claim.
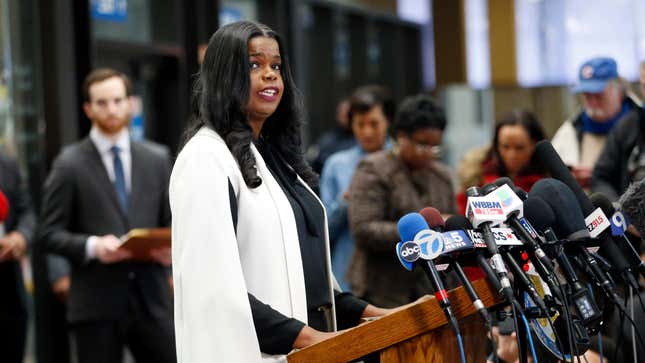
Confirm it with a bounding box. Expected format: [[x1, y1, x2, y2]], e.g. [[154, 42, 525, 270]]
[[529, 178, 618, 302]]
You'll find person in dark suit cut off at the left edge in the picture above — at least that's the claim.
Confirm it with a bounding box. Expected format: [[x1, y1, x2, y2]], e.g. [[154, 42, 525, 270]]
[[0, 149, 36, 363]]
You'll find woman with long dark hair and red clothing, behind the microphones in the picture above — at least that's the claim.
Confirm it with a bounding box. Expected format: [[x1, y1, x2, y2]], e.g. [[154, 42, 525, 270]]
[[457, 109, 545, 214]]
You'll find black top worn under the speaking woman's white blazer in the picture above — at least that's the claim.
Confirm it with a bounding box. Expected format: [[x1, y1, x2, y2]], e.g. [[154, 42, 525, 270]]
[[249, 141, 367, 354]]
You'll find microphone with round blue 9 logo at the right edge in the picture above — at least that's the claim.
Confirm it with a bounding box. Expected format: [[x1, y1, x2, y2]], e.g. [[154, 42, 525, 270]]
[[589, 193, 645, 282]]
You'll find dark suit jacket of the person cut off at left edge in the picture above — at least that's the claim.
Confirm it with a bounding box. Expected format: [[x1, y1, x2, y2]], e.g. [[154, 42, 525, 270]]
[[0, 153, 36, 319]]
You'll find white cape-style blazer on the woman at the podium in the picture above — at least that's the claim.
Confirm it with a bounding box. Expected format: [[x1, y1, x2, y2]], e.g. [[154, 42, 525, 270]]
[[170, 128, 339, 363]]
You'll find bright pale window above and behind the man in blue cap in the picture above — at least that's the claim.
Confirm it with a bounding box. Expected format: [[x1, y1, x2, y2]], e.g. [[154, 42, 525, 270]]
[[515, 0, 645, 86]]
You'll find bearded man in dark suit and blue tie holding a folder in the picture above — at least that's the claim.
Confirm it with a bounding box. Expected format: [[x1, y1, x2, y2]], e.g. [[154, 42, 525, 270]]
[[39, 69, 176, 363]]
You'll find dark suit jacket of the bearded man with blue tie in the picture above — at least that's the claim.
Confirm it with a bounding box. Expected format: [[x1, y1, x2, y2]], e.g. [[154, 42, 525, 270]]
[[38, 137, 172, 322]]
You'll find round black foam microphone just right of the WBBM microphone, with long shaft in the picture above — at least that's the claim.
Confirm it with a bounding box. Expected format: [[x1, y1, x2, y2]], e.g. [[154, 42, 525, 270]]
[[524, 196, 602, 326]]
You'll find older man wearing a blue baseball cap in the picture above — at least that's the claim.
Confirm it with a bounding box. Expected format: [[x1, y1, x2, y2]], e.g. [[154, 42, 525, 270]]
[[552, 57, 639, 187]]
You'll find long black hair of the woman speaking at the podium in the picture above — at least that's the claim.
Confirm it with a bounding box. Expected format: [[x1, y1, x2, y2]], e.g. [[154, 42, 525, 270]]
[[184, 21, 318, 190]]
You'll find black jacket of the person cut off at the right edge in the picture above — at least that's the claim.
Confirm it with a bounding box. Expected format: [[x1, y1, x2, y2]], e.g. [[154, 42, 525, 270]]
[[591, 107, 645, 201]]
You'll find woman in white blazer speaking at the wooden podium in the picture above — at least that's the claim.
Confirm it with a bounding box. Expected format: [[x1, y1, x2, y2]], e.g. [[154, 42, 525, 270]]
[[170, 21, 387, 362]]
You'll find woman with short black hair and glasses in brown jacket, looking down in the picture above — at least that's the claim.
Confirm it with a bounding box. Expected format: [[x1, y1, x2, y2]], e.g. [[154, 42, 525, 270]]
[[347, 95, 456, 307]]
